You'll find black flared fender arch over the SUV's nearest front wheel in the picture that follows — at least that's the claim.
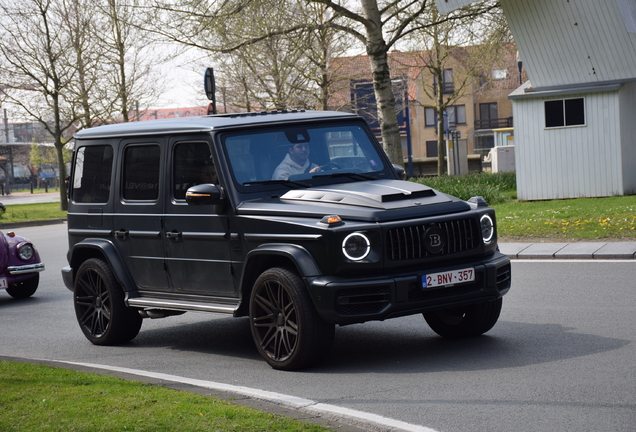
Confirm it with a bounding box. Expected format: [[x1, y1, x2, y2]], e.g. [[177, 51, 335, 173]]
[[235, 243, 322, 316]]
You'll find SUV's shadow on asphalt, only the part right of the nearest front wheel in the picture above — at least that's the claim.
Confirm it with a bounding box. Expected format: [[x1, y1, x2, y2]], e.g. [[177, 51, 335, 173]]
[[322, 321, 631, 374]]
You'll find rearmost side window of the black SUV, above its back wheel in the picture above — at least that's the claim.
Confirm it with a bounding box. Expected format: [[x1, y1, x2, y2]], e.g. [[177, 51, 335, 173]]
[[72, 145, 113, 203]]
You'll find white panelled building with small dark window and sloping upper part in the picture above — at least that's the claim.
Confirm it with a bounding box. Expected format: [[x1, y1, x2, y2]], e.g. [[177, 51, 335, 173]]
[[436, 0, 636, 200]]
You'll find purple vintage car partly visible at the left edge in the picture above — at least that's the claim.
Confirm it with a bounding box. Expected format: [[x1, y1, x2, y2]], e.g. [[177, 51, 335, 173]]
[[0, 231, 44, 298]]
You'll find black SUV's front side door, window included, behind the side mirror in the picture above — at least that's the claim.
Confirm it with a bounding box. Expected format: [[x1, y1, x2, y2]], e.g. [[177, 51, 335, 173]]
[[164, 137, 236, 297]]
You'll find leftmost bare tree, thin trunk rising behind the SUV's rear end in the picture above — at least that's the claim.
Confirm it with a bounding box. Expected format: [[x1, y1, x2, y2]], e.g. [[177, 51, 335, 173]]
[[0, 0, 78, 210]]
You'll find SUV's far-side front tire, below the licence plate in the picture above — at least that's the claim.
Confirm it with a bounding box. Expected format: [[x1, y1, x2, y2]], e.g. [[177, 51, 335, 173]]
[[423, 298, 503, 339]]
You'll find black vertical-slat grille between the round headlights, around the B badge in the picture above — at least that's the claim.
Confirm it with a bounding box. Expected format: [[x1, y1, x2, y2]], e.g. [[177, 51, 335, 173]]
[[386, 219, 479, 261]]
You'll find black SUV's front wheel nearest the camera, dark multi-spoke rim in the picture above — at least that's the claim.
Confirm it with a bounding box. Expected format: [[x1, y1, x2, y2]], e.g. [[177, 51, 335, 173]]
[[250, 268, 335, 371]]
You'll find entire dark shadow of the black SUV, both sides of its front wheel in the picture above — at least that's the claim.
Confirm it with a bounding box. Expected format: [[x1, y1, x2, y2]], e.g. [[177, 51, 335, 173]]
[[117, 317, 630, 373]]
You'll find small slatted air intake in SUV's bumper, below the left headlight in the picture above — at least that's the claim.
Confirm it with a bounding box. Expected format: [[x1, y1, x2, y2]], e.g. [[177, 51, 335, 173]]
[[335, 285, 390, 315]]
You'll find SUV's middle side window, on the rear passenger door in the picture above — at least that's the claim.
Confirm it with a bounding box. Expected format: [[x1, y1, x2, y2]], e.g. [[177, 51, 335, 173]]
[[122, 145, 161, 201]]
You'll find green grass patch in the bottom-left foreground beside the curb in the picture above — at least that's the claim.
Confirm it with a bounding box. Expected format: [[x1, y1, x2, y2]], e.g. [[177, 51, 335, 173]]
[[0, 361, 327, 432]]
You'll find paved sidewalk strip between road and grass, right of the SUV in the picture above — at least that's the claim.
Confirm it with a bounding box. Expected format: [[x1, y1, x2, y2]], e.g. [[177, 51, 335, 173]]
[[499, 241, 636, 259]]
